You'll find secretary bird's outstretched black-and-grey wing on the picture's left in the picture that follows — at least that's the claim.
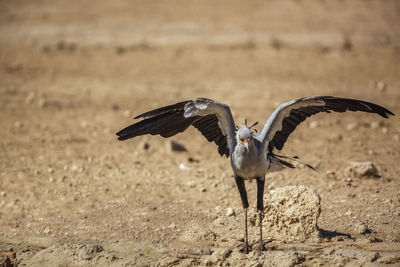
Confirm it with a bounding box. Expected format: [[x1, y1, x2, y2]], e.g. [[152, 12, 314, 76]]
[[117, 98, 235, 157]]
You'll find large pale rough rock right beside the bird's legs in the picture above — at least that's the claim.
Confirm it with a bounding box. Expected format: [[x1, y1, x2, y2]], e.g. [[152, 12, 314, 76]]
[[260, 185, 321, 242]]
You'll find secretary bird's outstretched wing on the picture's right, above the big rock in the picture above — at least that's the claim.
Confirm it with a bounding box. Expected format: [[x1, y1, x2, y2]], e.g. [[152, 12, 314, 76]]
[[257, 96, 394, 151]]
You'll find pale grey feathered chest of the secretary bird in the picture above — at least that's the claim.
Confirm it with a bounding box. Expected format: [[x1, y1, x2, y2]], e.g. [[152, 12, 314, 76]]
[[231, 148, 266, 179]]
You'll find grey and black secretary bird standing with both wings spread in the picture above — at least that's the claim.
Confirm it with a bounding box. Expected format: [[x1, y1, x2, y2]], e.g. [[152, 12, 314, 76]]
[[116, 96, 394, 253]]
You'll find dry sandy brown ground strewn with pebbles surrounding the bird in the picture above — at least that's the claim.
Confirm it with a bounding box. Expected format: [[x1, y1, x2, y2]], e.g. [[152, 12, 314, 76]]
[[0, 0, 400, 266]]
